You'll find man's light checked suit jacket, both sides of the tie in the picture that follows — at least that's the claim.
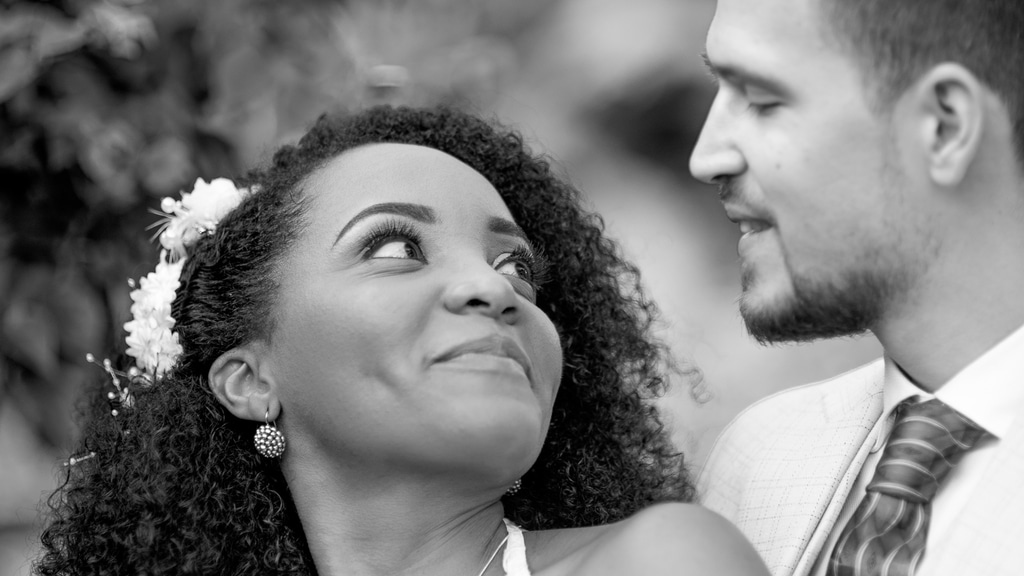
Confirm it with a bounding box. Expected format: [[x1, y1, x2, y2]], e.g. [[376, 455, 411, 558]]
[[697, 359, 1024, 576]]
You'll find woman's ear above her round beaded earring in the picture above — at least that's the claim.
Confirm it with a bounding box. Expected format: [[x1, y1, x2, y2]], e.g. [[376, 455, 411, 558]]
[[209, 344, 281, 422]]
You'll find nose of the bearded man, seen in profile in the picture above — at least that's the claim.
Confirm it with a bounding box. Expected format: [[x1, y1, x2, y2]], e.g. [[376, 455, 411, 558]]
[[690, 92, 746, 183]]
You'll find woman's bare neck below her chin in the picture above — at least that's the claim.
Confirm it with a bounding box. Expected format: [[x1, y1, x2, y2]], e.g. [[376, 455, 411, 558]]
[[285, 457, 505, 576]]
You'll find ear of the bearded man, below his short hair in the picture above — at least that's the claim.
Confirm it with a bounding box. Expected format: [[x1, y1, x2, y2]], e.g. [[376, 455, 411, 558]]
[[913, 63, 985, 188]]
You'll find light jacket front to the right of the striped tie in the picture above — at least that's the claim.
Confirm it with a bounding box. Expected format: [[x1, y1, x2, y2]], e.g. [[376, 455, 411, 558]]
[[926, 415, 1024, 576]]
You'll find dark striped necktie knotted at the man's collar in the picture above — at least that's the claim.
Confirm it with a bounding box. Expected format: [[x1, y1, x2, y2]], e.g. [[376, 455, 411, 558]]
[[827, 393, 985, 576]]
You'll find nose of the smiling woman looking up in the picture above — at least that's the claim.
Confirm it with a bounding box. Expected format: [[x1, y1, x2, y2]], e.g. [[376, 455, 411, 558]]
[[443, 262, 519, 324]]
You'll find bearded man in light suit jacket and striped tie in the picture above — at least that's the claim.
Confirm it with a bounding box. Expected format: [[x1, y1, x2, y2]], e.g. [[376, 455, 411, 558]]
[[690, 0, 1024, 576]]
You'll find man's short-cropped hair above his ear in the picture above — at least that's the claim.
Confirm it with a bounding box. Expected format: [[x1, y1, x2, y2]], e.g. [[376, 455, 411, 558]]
[[820, 0, 1024, 165]]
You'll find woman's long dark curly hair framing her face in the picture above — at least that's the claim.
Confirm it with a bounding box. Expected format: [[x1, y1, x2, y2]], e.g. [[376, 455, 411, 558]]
[[35, 107, 692, 575]]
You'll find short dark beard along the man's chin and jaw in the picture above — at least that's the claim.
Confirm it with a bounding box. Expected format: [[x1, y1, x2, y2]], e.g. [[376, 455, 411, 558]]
[[739, 264, 898, 344]]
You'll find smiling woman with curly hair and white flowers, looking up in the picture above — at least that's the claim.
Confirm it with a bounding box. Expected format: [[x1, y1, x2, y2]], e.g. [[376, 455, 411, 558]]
[[37, 108, 763, 576]]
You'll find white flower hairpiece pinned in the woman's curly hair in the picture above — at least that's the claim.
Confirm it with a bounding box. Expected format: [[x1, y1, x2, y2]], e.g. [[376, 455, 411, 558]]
[[124, 178, 248, 379]]
